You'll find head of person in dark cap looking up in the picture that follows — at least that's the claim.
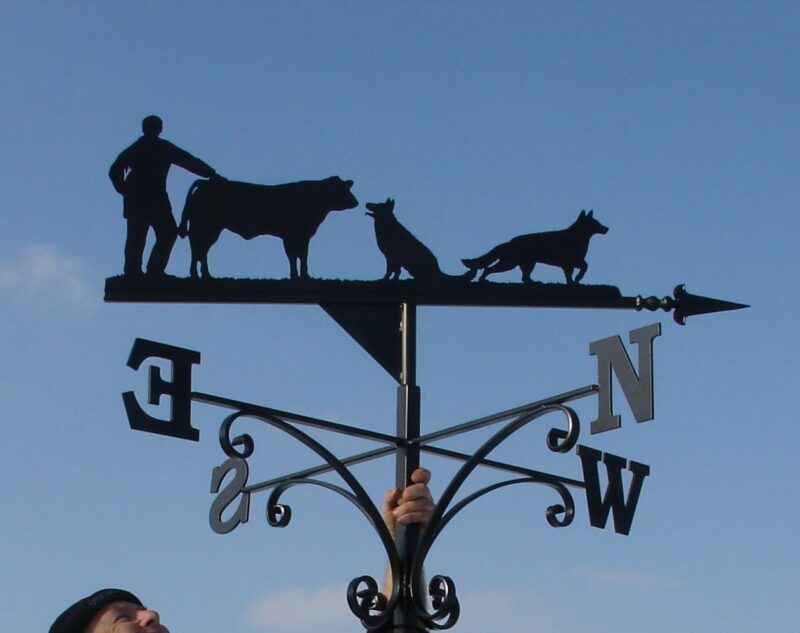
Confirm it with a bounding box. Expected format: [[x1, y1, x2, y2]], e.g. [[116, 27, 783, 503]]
[[50, 589, 169, 633]]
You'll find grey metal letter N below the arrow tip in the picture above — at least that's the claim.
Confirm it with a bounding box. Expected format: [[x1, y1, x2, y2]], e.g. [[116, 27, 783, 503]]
[[589, 323, 661, 434]]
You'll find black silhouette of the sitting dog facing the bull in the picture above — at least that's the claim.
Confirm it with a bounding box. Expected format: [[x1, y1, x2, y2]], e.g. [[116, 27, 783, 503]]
[[366, 198, 472, 280]]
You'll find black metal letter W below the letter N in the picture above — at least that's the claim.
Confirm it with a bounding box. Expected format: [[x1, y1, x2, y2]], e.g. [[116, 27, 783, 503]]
[[578, 445, 650, 534]]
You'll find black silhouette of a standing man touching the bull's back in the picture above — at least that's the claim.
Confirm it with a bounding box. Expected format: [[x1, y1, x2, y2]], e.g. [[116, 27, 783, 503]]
[[108, 115, 216, 275]]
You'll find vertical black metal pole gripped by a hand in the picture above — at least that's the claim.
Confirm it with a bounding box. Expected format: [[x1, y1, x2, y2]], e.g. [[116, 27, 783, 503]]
[[394, 303, 420, 633]]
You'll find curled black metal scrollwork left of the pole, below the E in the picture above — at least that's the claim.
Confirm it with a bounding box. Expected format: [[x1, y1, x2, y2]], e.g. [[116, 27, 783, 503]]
[[219, 411, 400, 631]]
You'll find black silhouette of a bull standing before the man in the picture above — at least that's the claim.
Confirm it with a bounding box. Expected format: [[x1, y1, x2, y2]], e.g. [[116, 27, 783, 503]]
[[178, 176, 358, 279]]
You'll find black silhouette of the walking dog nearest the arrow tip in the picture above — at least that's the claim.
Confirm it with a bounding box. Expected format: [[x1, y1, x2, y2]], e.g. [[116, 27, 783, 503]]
[[461, 211, 608, 284]]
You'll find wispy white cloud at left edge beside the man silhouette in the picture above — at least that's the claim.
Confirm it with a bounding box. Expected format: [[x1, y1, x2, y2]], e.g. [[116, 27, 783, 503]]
[[0, 245, 99, 309]]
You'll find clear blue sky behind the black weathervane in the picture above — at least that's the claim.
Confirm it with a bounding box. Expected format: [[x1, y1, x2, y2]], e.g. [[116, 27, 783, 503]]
[[0, 2, 800, 633]]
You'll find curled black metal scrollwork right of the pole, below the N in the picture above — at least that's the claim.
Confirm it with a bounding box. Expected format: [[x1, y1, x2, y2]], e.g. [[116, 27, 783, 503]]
[[410, 404, 580, 629]]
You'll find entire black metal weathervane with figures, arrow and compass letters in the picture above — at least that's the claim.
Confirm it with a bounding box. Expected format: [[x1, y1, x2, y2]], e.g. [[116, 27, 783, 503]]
[[105, 116, 747, 631]]
